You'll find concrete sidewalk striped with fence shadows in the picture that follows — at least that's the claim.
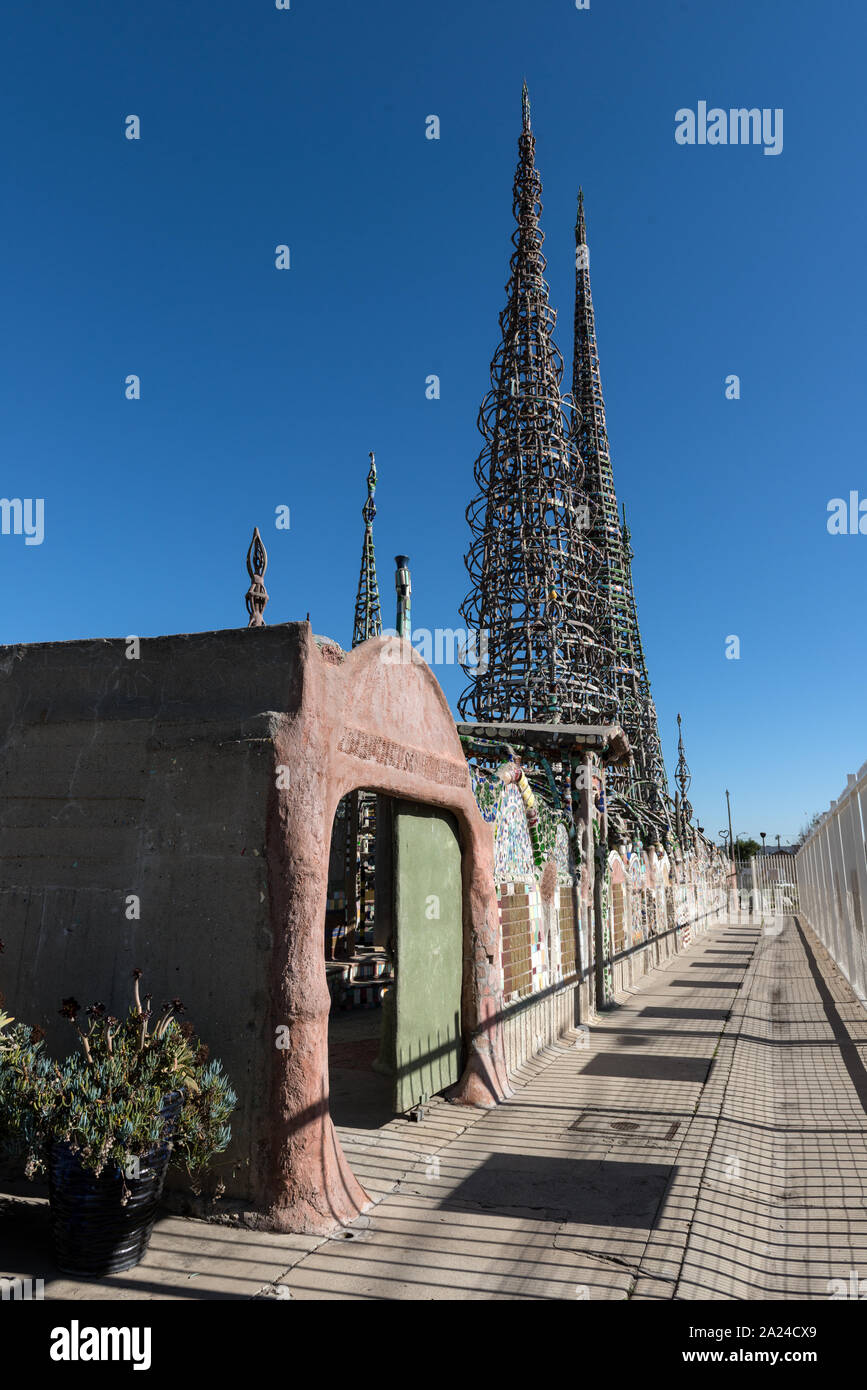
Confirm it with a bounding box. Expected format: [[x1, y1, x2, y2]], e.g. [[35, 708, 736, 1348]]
[[0, 919, 867, 1300]]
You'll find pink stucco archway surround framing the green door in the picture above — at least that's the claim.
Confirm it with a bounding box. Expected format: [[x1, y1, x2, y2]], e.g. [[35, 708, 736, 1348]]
[[254, 627, 509, 1233]]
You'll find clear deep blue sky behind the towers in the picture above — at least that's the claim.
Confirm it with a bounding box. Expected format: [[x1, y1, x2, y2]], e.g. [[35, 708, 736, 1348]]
[[0, 0, 867, 842]]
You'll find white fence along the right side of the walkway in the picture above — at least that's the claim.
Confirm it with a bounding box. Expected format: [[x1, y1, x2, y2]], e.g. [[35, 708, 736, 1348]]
[[795, 763, 867, 1002]]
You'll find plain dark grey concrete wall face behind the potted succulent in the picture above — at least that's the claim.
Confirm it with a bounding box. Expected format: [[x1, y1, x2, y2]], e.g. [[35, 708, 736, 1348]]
[[0, 632, 280, 1191]]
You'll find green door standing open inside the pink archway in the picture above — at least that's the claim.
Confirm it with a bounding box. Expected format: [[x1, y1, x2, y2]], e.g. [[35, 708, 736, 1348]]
[[393, 801, 463, 1112]]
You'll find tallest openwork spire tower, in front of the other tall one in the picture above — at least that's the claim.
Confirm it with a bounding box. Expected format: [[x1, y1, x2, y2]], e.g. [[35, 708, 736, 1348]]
[[459, 83, 604, 723]]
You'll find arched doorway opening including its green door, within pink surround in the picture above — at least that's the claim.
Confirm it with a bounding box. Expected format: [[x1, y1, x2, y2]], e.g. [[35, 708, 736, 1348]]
[[325, 792, 463, 1138]]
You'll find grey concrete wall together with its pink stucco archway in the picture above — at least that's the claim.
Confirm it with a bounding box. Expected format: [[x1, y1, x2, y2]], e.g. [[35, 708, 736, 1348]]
[[0, 623, 507, 1232]]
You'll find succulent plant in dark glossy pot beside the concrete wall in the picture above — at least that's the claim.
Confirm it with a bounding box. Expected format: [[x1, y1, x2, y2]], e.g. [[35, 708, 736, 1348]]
[[0, 970, 236, 1276]]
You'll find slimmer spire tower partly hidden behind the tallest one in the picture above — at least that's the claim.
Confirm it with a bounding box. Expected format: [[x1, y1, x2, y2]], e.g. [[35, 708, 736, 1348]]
[[572, 190, 668, 821]]
